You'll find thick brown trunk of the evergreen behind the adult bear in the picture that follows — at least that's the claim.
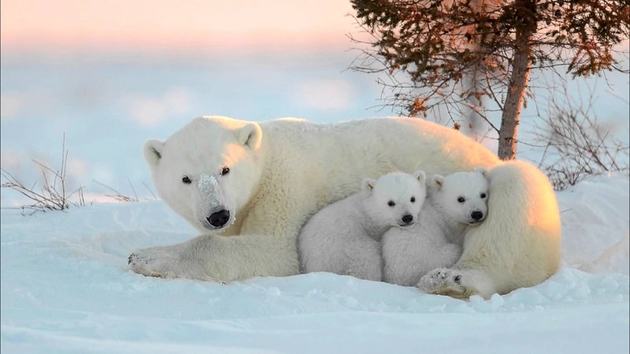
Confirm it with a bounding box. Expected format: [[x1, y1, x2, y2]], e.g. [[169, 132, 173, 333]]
[[498, 0, 536, 160]]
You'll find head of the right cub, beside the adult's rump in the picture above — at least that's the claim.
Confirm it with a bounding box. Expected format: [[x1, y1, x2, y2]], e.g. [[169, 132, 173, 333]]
[[430, 169, 488, 225]]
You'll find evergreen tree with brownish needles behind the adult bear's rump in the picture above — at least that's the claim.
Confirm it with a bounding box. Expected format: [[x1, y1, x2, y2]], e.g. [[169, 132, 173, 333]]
[[351, 0, 630, 159]]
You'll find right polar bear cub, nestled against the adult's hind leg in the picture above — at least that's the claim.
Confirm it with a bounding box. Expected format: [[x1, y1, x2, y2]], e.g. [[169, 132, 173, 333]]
[[383, 170, 488, 286]]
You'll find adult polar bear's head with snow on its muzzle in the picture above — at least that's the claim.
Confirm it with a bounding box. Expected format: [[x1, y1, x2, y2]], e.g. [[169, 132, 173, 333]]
[[144, 117, 262, 231]]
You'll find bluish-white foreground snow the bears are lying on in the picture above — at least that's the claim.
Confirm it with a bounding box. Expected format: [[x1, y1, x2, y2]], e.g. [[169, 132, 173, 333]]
[[0, 176, 629, 354]]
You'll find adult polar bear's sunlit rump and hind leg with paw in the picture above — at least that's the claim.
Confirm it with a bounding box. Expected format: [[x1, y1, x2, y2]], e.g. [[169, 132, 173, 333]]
[[418, 161, 561, 298]]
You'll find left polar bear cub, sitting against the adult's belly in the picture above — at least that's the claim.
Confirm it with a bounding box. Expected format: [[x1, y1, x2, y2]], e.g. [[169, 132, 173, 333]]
[[298, 171, 426, 280]]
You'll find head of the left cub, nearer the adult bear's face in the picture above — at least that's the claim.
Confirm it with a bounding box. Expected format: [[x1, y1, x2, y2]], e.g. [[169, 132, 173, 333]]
[[363, 171, 427, 227]]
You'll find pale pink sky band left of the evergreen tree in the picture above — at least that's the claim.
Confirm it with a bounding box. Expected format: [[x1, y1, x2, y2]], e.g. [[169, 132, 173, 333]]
[[1, 0, 354, 50]]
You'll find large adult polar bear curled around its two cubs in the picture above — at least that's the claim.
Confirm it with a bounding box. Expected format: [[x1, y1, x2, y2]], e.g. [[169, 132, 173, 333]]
[[129, 117, 560, 297]]
